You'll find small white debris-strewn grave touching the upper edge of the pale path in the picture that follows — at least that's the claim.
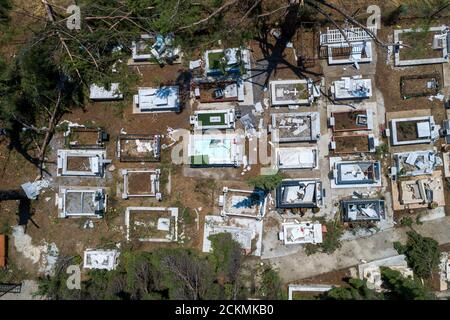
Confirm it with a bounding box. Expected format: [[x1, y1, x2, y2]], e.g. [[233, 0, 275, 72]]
[[280, 221, 322, 245]]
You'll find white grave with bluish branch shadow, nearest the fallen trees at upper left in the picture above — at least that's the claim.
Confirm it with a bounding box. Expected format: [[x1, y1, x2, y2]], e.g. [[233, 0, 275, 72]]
[[133, 86, 181, 113]]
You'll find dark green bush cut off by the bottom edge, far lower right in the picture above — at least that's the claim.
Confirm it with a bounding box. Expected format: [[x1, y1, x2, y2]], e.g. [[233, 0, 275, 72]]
[[380, 267, 436, 300]]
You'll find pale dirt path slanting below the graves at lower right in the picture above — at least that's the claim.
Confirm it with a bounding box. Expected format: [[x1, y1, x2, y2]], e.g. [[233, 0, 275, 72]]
[[266, 217, 450, 283]]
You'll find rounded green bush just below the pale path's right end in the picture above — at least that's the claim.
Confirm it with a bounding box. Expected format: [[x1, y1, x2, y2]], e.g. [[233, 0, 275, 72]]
[[394, 231, 441, 279]]
